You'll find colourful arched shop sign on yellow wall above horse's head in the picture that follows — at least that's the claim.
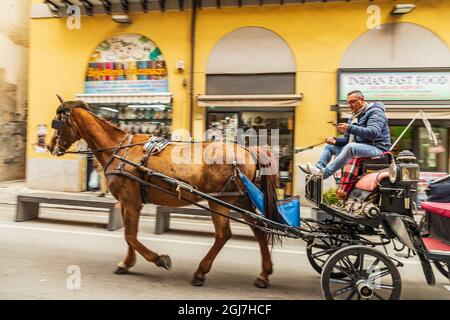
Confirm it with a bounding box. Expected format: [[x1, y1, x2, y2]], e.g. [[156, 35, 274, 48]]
[[85, 34, 168, 94]]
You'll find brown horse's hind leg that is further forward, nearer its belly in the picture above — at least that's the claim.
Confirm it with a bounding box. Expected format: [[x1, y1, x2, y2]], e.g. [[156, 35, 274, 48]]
[[191, 201, 231, 286]]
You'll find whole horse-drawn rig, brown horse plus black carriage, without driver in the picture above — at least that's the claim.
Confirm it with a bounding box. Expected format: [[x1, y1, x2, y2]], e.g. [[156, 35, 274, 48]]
[[49, 99, 450, 299]]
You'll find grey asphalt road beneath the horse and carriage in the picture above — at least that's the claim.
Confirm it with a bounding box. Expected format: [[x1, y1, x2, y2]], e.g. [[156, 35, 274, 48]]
[[0, 205, 450, 300]]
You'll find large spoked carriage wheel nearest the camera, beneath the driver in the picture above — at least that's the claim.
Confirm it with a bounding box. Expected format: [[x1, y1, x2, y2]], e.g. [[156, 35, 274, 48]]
[[321, 245, 402, 300]]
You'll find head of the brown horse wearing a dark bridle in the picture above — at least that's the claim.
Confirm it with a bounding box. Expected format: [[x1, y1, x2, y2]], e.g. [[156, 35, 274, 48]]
[[47, 95, 89, 156]]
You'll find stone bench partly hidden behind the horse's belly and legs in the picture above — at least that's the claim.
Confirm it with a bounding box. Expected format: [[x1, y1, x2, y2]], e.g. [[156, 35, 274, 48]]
[[154, 206, 241, 234]]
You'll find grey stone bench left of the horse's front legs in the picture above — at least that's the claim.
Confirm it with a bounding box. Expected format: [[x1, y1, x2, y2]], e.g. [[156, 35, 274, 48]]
[[15, 193, 123, 231]]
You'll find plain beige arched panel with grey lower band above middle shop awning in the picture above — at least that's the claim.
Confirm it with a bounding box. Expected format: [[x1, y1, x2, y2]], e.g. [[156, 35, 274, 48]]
[[206, 27, 296, 94]]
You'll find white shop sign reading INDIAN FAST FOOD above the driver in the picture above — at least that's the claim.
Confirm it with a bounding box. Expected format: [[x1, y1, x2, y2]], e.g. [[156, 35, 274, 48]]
[[339, 69, 450, 101]]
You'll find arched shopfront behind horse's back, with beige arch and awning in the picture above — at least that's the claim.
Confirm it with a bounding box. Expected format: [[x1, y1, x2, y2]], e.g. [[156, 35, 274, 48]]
[[198, 27, 301, 195]]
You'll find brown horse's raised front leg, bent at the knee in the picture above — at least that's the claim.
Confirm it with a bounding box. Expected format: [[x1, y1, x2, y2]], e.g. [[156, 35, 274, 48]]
[[115, 206, 172, 270]]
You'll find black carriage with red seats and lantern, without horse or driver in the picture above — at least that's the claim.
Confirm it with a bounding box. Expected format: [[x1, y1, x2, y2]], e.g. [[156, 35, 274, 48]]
[[306, 152, 450, 300]]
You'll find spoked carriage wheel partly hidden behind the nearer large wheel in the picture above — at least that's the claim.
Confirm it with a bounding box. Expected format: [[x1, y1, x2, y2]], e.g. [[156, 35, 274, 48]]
[[306, 238, 358, 279]]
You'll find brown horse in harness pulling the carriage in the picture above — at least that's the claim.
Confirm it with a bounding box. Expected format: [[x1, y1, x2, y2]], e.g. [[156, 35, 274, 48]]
[[48, 98, 280, 288]]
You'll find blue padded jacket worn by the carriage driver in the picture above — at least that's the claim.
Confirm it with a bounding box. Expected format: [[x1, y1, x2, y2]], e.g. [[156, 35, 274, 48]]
[[336, 102, 391, 151]]
